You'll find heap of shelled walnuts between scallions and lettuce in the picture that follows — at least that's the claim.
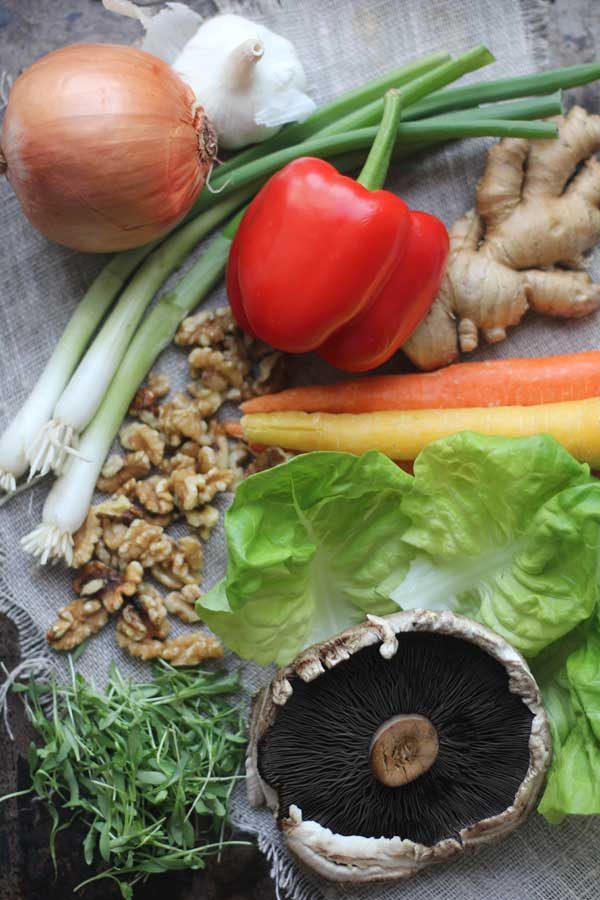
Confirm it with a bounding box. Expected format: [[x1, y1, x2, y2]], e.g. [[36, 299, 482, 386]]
[[48, 308, 284, 665]]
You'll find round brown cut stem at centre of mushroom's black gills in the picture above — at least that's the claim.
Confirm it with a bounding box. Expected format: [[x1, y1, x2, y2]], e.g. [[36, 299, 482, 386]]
[[369, 715, 439, 787]]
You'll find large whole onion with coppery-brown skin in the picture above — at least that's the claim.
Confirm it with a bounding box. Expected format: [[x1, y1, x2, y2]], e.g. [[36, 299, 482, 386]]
[[0, 44, 217, 252]]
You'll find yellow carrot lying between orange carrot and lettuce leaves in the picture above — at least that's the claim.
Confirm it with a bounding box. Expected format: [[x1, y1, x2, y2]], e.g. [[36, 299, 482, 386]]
[[241, 397, 600, 468]]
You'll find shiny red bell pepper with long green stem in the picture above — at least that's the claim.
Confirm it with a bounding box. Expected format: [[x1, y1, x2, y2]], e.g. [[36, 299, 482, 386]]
[[227, 91, 448, 371]]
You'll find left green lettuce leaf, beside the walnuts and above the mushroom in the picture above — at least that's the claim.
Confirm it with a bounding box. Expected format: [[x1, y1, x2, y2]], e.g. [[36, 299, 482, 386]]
[[198, 451, 414, 665]]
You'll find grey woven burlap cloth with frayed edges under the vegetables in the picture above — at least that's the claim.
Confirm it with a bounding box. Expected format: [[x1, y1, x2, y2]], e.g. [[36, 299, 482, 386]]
[[0, 0, 600, 900]]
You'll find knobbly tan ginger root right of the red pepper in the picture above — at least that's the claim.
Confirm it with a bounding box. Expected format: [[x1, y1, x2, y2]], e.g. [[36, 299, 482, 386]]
[[402, 106, 600, 369]]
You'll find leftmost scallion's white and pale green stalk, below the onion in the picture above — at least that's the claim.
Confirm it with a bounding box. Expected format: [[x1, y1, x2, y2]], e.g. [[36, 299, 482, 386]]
[[0, 243, 150, 492]]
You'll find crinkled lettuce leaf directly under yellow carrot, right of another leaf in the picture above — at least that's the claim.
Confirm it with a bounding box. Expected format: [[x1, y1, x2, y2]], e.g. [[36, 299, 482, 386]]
[[390, 432, 600, 657]]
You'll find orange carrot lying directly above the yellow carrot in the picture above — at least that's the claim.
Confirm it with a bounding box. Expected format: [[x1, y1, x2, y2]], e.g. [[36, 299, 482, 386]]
[[242, 350, 600, 413]]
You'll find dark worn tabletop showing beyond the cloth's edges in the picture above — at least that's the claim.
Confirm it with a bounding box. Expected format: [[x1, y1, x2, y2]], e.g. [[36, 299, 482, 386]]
[[0, 0, 600, 900]]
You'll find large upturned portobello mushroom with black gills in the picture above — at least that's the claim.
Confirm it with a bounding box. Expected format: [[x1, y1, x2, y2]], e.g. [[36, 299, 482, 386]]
[[247, 610, 550, 881]]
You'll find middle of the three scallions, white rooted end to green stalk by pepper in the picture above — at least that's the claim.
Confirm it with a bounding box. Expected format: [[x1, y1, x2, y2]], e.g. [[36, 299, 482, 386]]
[[25, 182, 258, 477]]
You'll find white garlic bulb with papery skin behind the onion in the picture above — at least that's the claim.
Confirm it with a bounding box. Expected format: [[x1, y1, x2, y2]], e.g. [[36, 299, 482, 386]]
[[103, 0, 315, 149]]
